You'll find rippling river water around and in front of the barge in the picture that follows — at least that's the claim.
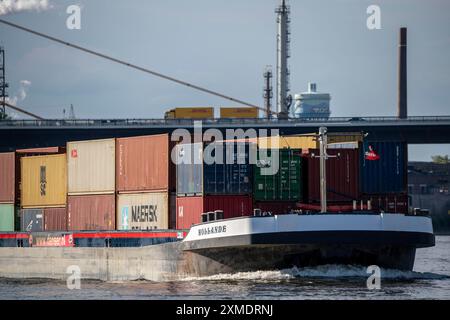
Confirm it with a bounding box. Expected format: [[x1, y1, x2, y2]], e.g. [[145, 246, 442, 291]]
[[0, 236, 450, 300]]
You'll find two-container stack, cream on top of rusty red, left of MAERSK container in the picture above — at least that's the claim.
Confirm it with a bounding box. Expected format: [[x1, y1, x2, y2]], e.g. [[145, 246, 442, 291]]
[[67, 139, 116, 231]]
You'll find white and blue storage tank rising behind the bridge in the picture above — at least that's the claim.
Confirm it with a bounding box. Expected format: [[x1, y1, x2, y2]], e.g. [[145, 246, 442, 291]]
[[293, 83, 331, 119]]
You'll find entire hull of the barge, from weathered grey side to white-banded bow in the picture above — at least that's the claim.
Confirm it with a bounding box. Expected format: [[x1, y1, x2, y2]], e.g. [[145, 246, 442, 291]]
[[0, 214, 435, 281]]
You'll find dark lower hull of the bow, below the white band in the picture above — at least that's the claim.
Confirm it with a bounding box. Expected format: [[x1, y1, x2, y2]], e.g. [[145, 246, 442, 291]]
[[185, 232, 434, 276]]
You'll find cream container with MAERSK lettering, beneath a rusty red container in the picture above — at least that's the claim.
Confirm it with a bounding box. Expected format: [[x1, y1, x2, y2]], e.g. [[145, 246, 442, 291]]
[[116, 192, 170, 230]]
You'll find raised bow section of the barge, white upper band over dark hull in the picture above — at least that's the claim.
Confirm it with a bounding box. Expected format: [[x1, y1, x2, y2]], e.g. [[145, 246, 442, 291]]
[[183, 214, 435, 276]]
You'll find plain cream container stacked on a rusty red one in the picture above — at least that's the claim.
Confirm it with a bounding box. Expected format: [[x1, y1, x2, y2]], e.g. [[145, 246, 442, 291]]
[[67, 139, 116, 195]]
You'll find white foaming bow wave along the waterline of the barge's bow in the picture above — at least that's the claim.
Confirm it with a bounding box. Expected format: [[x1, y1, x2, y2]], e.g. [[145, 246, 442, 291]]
[[182, 265, 450, 281]]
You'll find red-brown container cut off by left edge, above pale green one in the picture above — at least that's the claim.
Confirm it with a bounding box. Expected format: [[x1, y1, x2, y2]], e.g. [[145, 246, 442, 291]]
[[0, 152, 19, 203]]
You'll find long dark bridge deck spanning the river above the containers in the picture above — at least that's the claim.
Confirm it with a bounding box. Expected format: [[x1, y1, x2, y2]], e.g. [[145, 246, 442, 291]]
[[0, 116, 450, 151]]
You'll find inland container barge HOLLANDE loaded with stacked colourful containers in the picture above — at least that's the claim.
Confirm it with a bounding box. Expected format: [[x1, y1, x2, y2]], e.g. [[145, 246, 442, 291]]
[[0, 128, 435, 281]]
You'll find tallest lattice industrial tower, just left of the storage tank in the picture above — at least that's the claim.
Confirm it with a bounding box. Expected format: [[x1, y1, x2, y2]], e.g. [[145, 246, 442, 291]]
[[275, 0, 292, 119]]
